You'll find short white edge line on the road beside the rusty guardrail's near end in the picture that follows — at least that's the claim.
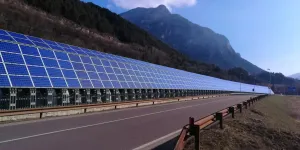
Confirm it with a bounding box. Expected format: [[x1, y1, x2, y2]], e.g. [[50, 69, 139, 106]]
[[133, 129, 182, 150]]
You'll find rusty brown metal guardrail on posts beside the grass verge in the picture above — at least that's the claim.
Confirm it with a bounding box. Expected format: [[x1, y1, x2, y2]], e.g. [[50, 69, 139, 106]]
[[174, 95, 268, 150]]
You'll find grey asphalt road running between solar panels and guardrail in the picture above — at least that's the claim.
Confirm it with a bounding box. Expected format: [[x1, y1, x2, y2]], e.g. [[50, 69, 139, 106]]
[[0, 95, 251, 150]]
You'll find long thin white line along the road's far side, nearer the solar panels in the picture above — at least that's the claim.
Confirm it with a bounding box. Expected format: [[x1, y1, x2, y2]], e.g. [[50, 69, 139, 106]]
[[0, 100, 226, 144]]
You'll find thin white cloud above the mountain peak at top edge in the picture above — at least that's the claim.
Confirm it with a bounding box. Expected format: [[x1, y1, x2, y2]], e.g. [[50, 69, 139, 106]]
[[111, 0, 197, 9]]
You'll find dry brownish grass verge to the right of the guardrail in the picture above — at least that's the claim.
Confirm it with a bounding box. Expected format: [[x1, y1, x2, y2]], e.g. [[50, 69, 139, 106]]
[[186, 96, 300, 150]]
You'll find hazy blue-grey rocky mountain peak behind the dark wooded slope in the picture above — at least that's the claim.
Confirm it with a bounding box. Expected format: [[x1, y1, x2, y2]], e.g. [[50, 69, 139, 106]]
[[120, 5, 263, 73]]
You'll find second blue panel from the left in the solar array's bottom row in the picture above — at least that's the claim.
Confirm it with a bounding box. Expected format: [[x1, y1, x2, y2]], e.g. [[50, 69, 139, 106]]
[[9, 75, 33, 87]]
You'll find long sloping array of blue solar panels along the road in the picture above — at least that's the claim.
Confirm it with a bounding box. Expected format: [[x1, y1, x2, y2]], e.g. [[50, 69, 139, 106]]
[[0, 30, 270, 93]]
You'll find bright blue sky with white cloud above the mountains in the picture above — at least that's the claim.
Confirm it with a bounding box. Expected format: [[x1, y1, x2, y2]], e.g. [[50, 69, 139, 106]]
[[83, 0, 300, 75]]
